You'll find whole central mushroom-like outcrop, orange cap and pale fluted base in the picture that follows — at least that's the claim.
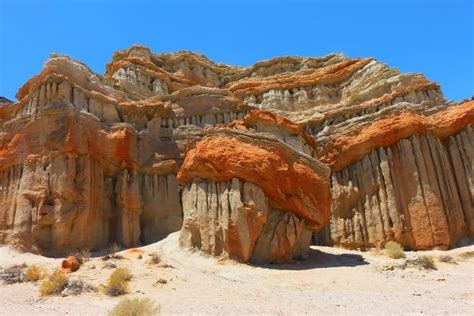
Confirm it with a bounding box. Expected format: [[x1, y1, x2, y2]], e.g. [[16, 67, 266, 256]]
[[178, 129, 331, 263]]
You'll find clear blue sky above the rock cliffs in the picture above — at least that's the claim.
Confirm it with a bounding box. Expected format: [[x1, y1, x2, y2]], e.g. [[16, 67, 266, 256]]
[[0, 0, 474, 100]]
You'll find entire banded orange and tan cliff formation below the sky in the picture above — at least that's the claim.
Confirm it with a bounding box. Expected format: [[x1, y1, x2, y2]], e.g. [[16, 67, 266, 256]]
[[0, 45, 474, 263]]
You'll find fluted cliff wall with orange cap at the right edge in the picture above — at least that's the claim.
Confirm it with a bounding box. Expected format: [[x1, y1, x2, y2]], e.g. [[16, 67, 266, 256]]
[[312, 101, 474, 249]]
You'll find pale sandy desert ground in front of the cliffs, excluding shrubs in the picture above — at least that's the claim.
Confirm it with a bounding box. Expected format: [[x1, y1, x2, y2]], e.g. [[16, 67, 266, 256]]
[[0, 233, 474, 315]]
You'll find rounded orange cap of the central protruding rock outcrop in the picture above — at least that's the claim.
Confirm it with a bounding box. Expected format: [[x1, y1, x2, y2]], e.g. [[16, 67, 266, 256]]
[[177, 130, 331, 228]]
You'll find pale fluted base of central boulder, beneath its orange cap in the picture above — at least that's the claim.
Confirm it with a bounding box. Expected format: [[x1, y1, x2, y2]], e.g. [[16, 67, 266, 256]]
[[180, 178, 312, 263]]
